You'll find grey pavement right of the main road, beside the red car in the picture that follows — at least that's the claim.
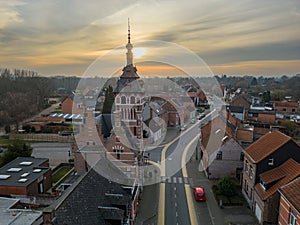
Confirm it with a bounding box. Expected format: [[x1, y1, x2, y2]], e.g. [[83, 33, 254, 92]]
[[186, 155, 258, 225]]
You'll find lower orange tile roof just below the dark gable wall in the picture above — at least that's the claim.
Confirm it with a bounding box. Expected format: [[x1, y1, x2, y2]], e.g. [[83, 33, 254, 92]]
[[255, 159, 300, 200]]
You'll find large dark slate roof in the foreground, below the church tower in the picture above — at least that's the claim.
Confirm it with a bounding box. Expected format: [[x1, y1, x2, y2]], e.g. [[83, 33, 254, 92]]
[[45, 158, 133, 225]]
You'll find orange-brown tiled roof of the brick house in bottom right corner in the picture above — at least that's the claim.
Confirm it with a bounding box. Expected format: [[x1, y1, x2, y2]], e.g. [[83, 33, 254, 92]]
[[279, 177, 300, 212]]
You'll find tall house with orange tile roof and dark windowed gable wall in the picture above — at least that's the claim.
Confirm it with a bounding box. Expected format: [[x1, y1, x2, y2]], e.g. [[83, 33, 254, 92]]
[[242, 131, 300, 209]]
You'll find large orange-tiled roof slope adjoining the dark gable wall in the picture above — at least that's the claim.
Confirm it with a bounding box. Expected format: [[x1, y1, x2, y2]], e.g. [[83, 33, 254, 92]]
[[245, 131, 292, 163]]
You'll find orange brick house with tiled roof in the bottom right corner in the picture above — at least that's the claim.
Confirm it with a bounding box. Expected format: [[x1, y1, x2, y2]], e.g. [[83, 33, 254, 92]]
[[278, 178, 300, 225]]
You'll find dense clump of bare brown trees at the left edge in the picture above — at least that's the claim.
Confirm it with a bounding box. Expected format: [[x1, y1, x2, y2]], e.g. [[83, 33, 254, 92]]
[[0, 69, 52, 128]]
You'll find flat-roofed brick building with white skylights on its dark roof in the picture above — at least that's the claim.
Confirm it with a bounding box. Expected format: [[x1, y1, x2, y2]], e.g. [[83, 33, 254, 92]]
[[0, 157, 52, 196]]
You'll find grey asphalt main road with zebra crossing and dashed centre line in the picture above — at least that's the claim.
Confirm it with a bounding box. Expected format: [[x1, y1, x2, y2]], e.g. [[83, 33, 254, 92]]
[[148, 107, 215, 225]]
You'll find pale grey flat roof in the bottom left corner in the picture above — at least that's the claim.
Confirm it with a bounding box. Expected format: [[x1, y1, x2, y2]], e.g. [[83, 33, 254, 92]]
[[0, 197, 43, 225]]
